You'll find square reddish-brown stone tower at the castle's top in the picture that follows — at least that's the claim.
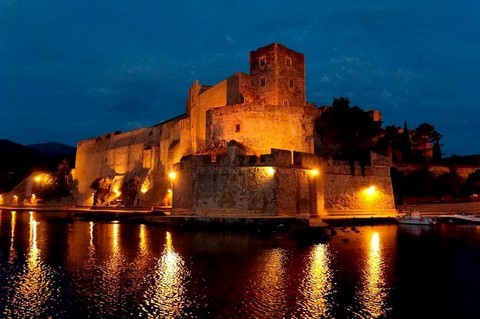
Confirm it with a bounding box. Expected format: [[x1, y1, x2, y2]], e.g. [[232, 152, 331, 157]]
[[250, 43, 305, 107]]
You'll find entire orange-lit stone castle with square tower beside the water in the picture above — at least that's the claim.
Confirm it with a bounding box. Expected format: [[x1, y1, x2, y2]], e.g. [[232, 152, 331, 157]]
[[74, 43, 394, 217]]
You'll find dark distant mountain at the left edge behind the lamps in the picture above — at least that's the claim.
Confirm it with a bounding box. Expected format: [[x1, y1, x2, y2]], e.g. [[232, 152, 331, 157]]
[[0, 139, 76, 193]]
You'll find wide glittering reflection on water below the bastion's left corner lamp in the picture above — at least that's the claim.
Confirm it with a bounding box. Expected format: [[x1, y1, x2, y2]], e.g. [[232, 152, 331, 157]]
[[142, 231, 190, 318]]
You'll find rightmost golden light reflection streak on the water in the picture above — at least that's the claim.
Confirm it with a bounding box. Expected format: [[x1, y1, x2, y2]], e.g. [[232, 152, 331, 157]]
[[357, 232, 388, 318]]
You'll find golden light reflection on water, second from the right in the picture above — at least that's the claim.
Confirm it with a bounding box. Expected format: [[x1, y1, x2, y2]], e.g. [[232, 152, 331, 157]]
[[296, 244, 334, 318]]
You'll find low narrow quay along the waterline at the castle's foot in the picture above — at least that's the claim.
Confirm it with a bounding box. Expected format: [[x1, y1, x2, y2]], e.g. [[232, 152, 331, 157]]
[[0, 202, 480, 229]]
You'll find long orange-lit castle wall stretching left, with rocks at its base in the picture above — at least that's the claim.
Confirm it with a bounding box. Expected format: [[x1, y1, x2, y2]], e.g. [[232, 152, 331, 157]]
[[74, 117, 191, 205]]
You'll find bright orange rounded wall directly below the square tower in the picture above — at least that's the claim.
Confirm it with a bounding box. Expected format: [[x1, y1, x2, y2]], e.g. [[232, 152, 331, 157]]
[[206, 104, 319, 155]]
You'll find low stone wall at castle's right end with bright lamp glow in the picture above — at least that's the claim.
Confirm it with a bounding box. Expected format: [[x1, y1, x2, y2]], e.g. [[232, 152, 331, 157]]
[[324, 153, 395, 215]]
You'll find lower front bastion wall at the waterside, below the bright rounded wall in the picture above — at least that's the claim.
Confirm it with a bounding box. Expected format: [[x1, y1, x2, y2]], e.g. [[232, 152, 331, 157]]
[[173, 147, 323, 217]]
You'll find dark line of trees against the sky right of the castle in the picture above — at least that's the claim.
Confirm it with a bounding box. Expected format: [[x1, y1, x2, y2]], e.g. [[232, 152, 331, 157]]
[[315, 97, 442, 163]]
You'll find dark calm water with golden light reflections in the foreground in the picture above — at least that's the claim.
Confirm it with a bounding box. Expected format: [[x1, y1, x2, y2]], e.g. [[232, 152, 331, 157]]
[[0, 210, 480, 318]]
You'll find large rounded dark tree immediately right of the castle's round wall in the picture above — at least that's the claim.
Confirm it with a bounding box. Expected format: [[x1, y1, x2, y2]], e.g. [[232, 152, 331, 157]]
[[316, 97, 382, 162]]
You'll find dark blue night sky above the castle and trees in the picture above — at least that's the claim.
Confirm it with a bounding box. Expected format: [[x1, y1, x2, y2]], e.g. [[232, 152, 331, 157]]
[[0, 0, 480, 156]]
